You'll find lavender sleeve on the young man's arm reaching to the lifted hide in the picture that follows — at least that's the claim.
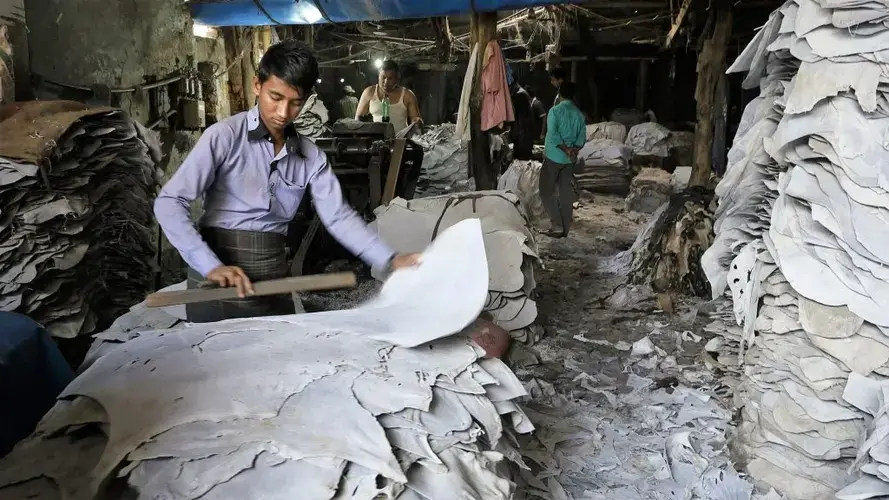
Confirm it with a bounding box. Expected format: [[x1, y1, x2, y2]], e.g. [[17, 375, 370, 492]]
[[306, 150, 395, 269]]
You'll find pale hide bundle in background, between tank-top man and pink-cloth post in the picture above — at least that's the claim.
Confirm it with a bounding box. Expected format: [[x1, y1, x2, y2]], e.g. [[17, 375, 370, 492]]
[[413, 123, 469, 197]]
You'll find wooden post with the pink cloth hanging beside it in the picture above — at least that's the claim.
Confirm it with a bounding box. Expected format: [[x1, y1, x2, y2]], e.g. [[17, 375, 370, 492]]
[[469, 12, 497, 191]]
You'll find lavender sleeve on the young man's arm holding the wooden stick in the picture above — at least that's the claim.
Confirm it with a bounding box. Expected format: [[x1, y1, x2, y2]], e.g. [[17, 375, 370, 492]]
[[154, 124, 234, 276]]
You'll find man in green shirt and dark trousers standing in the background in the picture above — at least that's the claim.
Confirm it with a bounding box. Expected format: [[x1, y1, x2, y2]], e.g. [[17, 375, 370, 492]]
[[540, 81, 586, 238]]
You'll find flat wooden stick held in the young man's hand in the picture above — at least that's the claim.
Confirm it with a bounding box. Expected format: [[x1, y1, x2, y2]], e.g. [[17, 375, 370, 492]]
[[145, 272, 358, 307]]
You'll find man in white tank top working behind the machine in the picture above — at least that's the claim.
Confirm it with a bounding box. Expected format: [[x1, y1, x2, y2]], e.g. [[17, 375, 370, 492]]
[[355, 61, 423, 132]]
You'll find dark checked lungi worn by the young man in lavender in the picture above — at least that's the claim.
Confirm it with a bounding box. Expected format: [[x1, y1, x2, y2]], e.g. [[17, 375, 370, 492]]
[[185, 228, 294, 323]]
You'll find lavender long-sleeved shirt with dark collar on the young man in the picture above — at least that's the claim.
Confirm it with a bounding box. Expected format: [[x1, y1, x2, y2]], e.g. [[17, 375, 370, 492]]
[[154, 107, 394, 276]]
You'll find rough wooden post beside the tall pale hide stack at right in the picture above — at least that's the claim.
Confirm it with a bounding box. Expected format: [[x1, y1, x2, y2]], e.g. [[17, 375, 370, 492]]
[[689, 1, 732, 186]]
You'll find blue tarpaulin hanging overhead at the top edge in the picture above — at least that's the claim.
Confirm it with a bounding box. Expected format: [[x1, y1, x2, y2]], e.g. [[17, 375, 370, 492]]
[[189, 0, 566, 26]]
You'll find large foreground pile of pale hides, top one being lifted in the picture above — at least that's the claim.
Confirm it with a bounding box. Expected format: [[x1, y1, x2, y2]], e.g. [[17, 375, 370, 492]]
[[0, 220, 533, 500]]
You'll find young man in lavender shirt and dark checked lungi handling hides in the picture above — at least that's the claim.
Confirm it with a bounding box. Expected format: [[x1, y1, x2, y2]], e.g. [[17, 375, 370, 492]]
[[154, 40, 418, 322]]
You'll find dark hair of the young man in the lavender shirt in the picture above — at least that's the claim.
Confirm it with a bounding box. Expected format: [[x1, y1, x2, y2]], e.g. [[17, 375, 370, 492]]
[[256, 38, 318, 92]]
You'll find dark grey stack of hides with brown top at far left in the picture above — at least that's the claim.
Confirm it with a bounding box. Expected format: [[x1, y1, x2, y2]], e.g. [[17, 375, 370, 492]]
[[0, 101, 161, 338]]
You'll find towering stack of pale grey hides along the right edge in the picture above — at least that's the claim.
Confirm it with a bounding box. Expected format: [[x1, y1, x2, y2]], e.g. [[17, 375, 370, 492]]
[[703, 0, 889, 500]]
